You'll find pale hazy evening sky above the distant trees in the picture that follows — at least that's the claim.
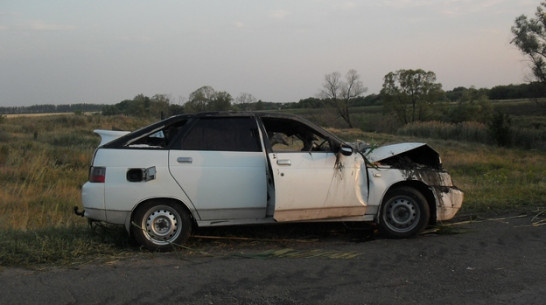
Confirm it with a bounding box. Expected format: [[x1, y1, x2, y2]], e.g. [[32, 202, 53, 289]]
[[0, 0, 540, 106]]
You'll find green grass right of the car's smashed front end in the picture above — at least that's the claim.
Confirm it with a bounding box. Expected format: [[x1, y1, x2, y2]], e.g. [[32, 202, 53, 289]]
[[430, 141, 546, 213]]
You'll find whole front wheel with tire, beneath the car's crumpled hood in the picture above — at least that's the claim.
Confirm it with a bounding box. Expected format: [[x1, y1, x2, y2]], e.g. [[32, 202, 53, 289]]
[[379, 187, 430, 238]]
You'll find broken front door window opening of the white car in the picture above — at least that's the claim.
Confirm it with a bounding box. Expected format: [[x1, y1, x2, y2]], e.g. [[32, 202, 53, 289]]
[[262, 118, 332, 152]]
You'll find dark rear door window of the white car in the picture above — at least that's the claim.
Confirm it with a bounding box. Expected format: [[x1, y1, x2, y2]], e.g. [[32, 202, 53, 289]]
[[181, 117, 262, 152]]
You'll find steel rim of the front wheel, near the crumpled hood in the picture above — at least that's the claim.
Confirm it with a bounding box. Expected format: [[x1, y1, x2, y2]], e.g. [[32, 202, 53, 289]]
[[385, 197, 420, 233]]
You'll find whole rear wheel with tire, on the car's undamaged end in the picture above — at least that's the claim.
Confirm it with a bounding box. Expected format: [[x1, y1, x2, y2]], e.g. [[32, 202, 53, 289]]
[[132, 201, 192, 251]]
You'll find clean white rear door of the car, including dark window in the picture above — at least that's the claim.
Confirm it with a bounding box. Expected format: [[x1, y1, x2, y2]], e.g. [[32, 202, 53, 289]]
[[169, 117, 267, 220]]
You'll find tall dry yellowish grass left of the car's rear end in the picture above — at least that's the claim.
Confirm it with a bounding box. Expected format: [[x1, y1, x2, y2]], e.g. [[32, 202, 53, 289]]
[[0, 115, 151, 231]]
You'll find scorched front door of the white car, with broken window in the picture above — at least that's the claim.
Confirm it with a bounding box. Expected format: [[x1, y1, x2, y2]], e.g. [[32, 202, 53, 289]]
[[262, 117, 367, 221]]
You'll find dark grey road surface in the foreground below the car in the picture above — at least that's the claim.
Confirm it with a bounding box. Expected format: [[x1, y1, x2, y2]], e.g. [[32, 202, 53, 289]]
[[0, 213, 546, 305]]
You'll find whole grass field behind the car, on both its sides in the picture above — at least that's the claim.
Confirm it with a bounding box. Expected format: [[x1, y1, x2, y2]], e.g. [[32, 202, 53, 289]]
[[0, 114, 546, 266]]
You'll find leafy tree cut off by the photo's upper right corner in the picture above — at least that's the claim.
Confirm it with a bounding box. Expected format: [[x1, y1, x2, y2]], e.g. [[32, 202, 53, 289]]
[[511, 1, 546, 85]]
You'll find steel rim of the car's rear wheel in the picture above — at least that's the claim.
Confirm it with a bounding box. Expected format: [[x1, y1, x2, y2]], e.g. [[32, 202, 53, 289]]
[[142, 206, 183, 245]]
